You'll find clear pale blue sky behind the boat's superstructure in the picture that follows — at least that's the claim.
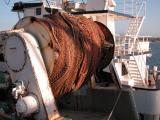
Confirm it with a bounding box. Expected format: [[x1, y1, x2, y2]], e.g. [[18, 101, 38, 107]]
[[0, 0, 160, 37]]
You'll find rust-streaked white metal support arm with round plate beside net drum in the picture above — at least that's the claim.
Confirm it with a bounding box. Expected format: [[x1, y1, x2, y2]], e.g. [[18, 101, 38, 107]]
[[4, 31, 60, 120]]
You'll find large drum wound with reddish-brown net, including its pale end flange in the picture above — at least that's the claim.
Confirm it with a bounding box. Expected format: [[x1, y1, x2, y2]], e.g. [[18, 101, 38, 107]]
[[14, 12, 114, 97]]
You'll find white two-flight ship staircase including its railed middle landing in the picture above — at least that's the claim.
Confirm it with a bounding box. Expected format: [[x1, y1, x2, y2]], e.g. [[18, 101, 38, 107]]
[[115, 0, 146, 88]]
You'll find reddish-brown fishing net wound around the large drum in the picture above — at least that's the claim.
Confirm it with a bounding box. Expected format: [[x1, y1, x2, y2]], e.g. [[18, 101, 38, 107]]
[[41, 13, 114, 96]]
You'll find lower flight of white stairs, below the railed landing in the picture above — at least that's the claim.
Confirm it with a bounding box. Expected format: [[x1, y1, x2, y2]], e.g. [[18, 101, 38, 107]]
[[127, 60, 145, 87]]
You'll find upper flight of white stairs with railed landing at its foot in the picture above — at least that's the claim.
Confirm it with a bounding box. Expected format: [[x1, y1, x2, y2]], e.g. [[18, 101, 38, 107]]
[[115, 16, 145, 56]]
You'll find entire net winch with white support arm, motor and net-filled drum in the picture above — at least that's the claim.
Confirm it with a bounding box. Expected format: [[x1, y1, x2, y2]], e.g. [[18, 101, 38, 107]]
[[0, 12, 114, 120]]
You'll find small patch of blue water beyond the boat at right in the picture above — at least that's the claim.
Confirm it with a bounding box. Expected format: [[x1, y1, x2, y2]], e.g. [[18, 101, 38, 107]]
[[147, 41, 160, 68]]
